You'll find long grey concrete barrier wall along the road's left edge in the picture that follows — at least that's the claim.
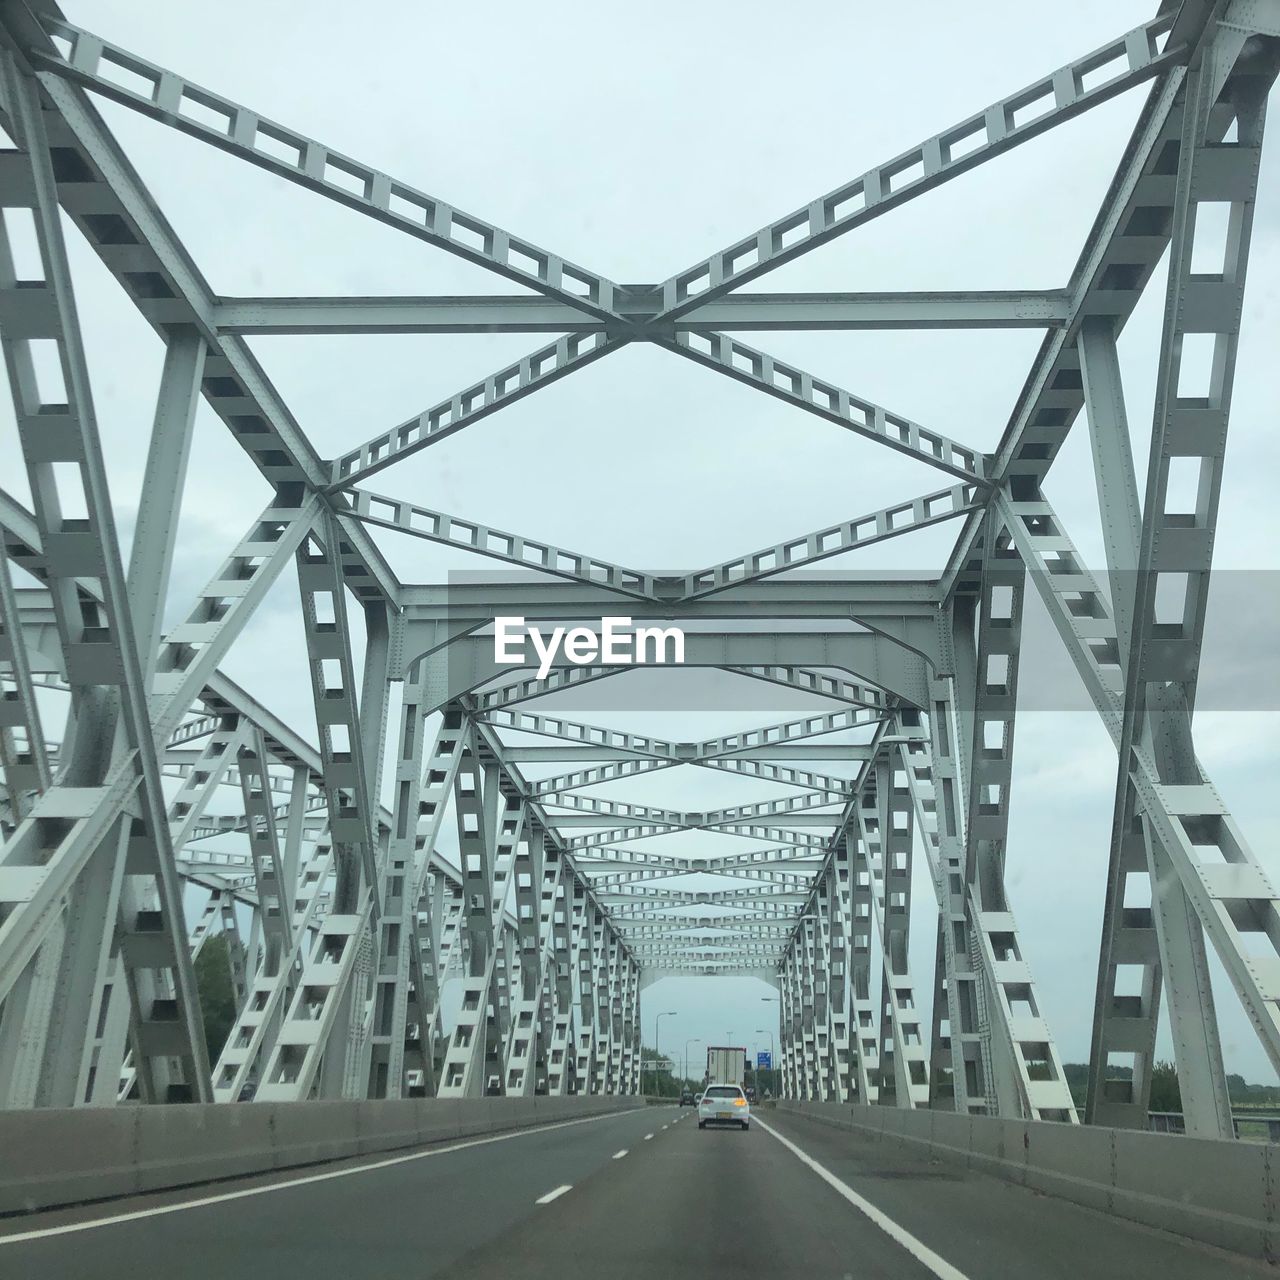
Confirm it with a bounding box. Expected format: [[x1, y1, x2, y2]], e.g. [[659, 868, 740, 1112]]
[[0, 1096, 641, 1213]]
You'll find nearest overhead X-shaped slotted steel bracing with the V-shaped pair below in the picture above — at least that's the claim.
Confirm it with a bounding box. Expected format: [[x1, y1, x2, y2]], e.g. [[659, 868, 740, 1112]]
[[33, 14, 1196, 598]]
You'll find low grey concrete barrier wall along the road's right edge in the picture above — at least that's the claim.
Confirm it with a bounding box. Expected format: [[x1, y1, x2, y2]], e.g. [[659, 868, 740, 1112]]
[[778, 1100, 1280, 1261]]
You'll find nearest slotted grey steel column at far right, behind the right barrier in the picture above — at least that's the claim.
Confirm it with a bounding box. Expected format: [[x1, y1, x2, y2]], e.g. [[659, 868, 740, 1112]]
[[1089, 42, 1276, 1138]]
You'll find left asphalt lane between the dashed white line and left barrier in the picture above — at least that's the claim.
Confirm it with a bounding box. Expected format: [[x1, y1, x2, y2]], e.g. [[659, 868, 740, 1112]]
[[0, 1107, 660, 1280]]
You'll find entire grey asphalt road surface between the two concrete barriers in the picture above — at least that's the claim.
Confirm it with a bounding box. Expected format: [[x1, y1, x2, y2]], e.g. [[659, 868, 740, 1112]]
[[0, 1107, 1274, 1280]]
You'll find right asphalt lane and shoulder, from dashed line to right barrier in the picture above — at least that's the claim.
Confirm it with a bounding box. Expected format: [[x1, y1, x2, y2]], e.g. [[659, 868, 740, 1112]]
[[439, 1110, 1274, 1280]]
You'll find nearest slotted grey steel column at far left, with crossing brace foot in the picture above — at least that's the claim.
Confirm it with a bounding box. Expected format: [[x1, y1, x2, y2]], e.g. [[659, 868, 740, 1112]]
[[0, 54, 210, 1105]]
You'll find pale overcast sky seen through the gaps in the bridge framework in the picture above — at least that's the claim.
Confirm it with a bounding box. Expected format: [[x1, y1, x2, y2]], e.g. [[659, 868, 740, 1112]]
[[10, 0, 1280, 1080]]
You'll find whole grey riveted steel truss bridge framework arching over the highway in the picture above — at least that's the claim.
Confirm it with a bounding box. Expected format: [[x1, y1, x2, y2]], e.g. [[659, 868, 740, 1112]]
[[0, 0, 1280, 1152]]
